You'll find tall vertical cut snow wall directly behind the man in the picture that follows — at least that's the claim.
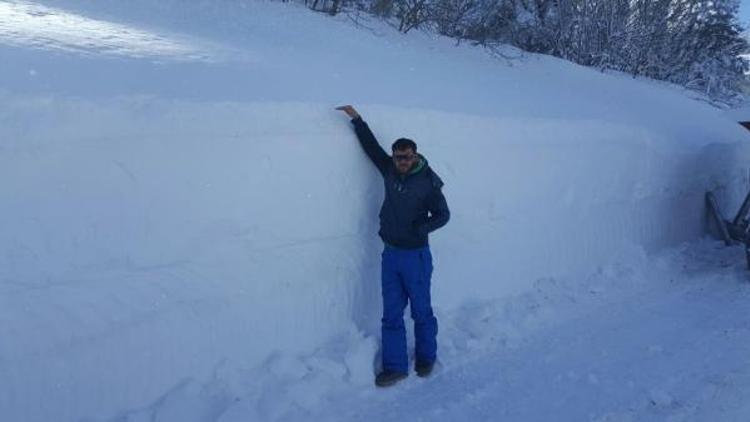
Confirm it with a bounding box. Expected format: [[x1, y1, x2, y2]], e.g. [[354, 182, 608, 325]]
[[0, 98, 750, 420]]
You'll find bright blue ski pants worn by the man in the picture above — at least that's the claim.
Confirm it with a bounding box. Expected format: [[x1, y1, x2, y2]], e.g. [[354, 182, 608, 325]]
[[381, 245, 437, 373]]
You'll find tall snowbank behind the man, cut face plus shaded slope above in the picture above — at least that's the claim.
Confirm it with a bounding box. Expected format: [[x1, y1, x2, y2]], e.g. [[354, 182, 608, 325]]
[[0, 0, 750, 421]]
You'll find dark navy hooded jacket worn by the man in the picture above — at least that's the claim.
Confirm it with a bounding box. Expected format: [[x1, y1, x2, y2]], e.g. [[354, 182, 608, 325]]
[[352, 117, 450, 249]]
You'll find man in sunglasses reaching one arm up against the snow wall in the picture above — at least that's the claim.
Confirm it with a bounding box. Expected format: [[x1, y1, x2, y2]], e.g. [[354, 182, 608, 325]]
[[336, 105, 450, 387]]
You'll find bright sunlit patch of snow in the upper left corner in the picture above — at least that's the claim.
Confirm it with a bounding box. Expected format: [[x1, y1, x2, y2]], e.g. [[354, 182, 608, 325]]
[[0, 1, 223, 62]]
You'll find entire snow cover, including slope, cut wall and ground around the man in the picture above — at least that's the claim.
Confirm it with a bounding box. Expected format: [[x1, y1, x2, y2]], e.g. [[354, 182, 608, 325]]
[[0, 0, 750, 422]]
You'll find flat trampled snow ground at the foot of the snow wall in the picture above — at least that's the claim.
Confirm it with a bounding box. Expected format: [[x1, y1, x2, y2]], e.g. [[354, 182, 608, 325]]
[[216, 241, 750, 422]]
